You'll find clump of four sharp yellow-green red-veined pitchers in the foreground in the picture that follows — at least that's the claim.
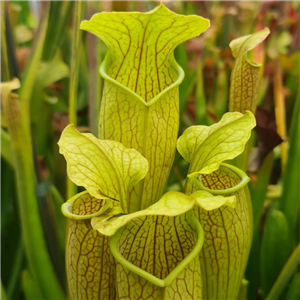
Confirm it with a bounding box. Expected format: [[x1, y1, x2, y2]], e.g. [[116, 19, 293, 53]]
[[59, 4, 264, 300]]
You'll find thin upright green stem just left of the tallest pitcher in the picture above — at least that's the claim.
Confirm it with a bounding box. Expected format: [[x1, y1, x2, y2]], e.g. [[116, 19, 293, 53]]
[[67, 0, 84, 199]]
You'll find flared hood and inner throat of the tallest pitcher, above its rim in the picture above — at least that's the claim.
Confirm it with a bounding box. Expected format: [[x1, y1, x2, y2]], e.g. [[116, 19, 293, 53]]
[[81, 5, 209, 102]]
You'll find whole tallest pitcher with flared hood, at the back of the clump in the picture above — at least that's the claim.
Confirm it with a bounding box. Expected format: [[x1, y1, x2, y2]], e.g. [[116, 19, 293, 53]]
[[81, 4, 209, 212]]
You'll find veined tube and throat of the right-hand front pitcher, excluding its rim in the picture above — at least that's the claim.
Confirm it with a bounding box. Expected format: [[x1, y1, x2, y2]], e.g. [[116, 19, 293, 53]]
[[187, 166, 252, 300]]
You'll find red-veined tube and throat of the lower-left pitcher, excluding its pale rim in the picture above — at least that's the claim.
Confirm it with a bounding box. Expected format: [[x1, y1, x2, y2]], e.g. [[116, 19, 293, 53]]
[[66, 193, 115, 300]]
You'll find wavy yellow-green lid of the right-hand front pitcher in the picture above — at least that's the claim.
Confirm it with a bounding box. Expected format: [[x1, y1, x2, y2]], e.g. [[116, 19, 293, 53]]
[[177, 112, 256, 176]]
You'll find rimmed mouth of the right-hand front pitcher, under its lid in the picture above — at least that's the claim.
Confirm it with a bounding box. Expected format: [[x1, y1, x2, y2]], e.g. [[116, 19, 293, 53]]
[[197, 163, 250, 195]]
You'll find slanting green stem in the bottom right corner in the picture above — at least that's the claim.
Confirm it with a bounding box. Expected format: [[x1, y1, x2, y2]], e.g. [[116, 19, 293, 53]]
[[265, 244, 300, 300]]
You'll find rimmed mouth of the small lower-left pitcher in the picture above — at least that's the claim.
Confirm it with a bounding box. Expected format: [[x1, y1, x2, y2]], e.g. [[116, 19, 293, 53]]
[[61, 191, 111, 220]]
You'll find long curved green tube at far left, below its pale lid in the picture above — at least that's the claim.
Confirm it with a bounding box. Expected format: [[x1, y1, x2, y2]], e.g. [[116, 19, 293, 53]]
[[2, 95, 64, 300]]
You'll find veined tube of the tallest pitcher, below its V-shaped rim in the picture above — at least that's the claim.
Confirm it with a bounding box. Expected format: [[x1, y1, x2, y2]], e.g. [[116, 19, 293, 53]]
[[99, 82, 179, 212]]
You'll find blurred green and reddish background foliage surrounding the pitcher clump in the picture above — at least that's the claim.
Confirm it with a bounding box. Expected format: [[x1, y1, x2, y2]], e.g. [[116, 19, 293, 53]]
[[0, 0, 300, 300]]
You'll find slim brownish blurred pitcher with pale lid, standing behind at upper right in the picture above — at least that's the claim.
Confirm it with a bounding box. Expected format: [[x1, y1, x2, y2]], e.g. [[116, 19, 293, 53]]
[[229, 28, 270, 113]]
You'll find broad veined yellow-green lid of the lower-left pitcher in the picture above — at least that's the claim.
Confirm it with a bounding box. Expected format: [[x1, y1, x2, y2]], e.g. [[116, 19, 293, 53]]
[[58, 125, 148, 212]]
